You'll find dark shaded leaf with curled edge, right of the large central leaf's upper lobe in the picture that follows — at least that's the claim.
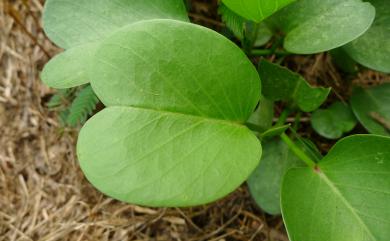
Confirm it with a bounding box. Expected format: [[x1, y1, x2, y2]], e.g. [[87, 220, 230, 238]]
[[259, 60, 330, 112]]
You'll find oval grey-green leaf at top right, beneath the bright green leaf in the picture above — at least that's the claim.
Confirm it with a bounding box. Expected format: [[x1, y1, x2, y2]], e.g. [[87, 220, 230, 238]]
[[270, 0, 375, 54]]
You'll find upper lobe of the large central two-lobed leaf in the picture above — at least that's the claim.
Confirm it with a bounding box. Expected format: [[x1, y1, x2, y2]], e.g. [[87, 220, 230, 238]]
[[91, 20, 260, 123]]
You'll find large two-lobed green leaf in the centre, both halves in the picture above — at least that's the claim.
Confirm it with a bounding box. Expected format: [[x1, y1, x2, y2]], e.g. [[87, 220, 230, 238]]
[[77, 20, 261, 206]]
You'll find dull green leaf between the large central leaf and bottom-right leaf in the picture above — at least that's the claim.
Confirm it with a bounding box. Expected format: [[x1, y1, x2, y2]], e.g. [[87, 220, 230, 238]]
[[247, 138, 304, 215]]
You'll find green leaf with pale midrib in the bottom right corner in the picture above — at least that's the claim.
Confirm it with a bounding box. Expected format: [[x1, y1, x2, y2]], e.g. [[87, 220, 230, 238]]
[[281, 135, 390, 241]]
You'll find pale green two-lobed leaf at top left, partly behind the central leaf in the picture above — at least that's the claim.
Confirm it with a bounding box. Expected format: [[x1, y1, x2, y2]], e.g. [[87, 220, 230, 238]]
[[41, 0, 188, 88]]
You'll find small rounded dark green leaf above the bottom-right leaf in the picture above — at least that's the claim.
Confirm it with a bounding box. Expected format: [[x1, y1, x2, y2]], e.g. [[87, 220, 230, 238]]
[[311, 101, 357, 139]]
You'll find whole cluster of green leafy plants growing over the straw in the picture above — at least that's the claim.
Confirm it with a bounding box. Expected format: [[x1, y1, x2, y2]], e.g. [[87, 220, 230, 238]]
[[41, 0, 390, 241]]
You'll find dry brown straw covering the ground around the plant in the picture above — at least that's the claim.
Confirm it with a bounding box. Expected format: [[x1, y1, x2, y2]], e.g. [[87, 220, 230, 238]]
[[0, 0, 287, 241]]
